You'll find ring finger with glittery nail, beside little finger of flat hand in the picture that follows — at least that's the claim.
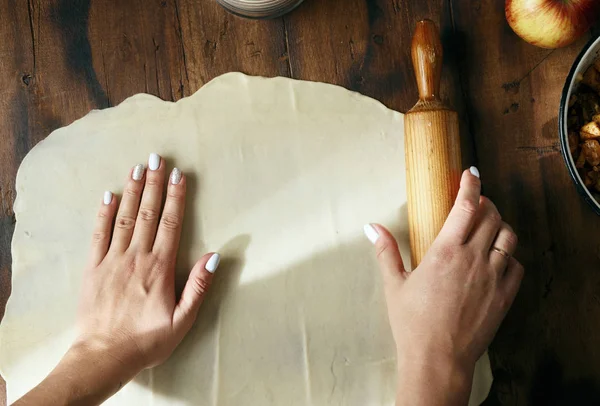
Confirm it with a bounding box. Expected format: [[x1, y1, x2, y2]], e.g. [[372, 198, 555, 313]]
[[110, 164, 144, 252]]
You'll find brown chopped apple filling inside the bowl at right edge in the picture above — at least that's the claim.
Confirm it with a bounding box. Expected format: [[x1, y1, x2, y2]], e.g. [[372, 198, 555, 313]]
[[567, 59, 600, 199]]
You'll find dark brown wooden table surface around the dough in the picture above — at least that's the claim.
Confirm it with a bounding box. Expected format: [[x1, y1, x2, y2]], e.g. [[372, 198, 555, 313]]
[[0, 0, 600, 405]]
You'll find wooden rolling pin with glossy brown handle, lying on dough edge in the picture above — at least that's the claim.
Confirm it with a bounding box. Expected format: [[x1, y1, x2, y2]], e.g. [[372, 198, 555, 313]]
[[404, 20, 462, 269]]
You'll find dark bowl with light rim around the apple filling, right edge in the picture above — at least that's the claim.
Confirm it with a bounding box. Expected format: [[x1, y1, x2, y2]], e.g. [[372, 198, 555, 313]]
[[558, 36, 600, 215]]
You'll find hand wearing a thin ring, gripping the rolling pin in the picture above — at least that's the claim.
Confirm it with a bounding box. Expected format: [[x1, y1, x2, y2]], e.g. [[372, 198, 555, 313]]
[[365, 168, 523, 405]]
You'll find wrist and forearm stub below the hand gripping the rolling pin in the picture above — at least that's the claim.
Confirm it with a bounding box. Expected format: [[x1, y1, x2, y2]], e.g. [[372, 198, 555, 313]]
[[396, 357, 474, 406]]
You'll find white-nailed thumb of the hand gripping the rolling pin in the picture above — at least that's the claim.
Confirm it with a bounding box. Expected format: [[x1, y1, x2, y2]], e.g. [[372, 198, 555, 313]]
[[364, 224, 408, 286]]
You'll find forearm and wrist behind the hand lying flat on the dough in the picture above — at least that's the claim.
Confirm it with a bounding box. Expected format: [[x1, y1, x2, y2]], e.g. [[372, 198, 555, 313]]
[[13, 344, 138, 406]]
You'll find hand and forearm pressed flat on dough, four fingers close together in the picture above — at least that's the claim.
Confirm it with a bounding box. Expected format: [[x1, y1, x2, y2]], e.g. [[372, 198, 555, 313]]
[[17, 154, 220, 406]]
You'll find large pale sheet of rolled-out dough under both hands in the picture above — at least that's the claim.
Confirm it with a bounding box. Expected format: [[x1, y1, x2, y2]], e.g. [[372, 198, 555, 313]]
[[0, 73, 491, 406]]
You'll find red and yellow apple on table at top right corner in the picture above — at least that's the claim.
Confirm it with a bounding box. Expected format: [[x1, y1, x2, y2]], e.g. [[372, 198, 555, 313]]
[[505, 0, 600, 48]]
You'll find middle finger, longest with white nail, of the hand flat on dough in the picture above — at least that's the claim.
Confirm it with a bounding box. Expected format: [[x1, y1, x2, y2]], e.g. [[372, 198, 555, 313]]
[[131, 153, 165, 251]]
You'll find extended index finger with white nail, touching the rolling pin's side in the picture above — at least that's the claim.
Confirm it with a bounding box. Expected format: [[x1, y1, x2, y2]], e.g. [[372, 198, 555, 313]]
[[438, 166, 481, 245]]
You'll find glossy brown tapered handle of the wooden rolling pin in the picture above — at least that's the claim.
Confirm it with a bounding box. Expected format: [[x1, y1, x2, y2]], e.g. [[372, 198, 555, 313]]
[[411, 20, 444, 101]]
